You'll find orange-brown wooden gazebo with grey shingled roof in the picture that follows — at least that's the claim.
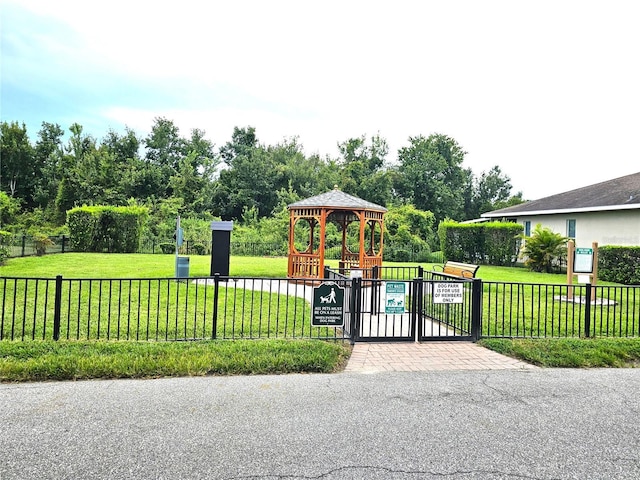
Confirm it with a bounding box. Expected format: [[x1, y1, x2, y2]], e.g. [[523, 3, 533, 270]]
[[287, 187, 387, 278]]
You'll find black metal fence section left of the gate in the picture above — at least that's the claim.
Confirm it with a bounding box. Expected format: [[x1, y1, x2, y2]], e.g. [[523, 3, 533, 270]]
[[0, 276, 349, 341]]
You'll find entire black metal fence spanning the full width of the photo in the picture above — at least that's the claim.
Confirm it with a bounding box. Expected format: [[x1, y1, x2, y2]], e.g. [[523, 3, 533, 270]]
[[0, 267, 640, 341]]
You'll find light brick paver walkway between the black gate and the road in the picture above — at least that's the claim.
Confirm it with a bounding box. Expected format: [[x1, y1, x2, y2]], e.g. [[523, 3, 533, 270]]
[[345, 342, 538, 373]]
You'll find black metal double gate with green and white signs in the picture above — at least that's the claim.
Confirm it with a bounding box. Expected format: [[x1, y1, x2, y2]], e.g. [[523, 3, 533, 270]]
[[347, 278, 482, 342]]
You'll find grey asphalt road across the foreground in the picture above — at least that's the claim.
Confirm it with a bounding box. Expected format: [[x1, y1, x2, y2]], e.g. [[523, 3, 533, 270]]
[[0, 369, 640, 480]]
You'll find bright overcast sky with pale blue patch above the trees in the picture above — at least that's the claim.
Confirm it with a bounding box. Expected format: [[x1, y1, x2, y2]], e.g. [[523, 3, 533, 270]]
[[0, 0, 640, 200]]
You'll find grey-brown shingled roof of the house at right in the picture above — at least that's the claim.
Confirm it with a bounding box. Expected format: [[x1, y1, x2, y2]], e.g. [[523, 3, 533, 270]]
[[482, 172, 640, 217]]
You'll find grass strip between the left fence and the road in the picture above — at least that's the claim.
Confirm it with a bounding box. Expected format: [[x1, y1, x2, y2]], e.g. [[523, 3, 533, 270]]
[[0, 340, 350, 382]]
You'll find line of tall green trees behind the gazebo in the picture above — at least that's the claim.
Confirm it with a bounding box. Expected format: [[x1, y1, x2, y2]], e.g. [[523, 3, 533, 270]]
[[0, 117, 523, 240]]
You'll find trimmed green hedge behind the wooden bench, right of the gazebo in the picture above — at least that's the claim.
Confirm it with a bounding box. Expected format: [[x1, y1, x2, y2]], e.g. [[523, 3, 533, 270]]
[[438, 221, 523, 266]]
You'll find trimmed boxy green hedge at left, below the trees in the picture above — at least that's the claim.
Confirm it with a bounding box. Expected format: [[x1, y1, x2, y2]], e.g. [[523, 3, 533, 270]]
[[67, 206, 149, 253]]
